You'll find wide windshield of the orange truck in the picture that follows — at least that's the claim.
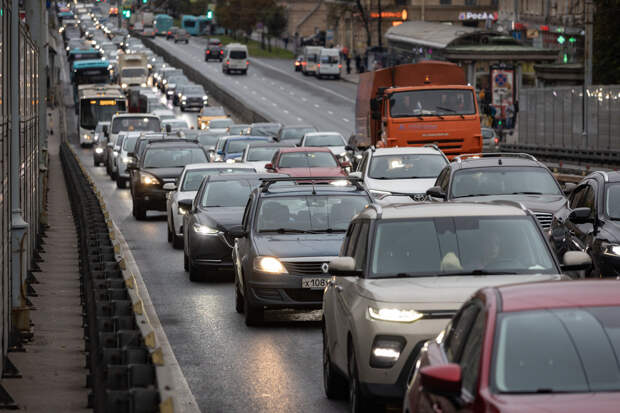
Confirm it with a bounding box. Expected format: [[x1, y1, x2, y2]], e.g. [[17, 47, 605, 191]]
[[390, 89, 476, 118]]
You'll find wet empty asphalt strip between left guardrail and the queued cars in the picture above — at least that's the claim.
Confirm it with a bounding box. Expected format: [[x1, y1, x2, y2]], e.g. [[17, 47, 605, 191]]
[[63, 45, 347, 412]]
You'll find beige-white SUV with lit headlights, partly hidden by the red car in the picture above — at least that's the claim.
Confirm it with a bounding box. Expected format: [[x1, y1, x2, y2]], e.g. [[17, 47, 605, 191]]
[[323, 202, 590, 412]]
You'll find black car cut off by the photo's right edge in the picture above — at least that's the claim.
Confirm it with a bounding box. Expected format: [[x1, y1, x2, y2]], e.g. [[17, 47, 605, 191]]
[[551, 171, 620, 278]]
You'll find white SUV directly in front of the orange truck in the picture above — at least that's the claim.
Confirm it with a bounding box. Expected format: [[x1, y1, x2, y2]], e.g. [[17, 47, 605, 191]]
[[351, 145, 449, 202]]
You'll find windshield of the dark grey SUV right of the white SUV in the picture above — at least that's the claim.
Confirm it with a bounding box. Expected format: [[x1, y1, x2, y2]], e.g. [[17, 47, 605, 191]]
[[451, 167, 561, 198]]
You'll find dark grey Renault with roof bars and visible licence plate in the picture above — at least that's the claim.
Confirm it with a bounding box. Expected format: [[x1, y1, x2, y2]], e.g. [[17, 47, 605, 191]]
[[232, 177, 371, 326]]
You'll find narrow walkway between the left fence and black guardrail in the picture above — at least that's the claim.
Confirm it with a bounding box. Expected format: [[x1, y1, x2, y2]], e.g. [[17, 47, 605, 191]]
[[2, 110, 91, 413]]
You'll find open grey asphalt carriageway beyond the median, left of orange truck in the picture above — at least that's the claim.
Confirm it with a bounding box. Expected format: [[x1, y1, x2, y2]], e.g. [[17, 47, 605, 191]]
[[150, 37, 357, 137]]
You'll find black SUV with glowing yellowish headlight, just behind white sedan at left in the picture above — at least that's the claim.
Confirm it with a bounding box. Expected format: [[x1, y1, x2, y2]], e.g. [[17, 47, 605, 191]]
[[127, 140, 207, 220]]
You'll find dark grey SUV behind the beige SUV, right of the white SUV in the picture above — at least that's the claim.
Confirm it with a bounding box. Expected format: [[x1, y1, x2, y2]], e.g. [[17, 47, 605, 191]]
[[426, 153, 568, 230]]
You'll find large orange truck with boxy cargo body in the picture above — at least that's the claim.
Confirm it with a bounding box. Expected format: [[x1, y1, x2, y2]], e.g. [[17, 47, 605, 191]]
[[355, 61, 482, 158]]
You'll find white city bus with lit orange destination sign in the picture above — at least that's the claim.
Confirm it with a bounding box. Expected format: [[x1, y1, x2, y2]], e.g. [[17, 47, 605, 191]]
[[76, 84, 127, 146]]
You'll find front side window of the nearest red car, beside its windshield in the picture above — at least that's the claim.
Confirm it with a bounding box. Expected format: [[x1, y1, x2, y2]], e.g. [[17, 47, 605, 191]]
[[459, 311, 486, 396]]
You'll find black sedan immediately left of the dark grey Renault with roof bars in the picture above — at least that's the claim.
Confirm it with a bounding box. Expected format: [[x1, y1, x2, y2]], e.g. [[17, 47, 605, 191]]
[[179, 173, 276, 281]]
